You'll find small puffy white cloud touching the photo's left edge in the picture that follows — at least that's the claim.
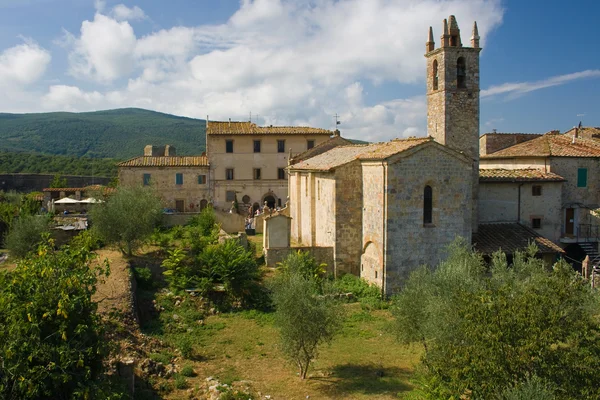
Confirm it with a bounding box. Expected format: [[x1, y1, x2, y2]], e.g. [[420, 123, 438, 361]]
[[0, 40, 52, 86]]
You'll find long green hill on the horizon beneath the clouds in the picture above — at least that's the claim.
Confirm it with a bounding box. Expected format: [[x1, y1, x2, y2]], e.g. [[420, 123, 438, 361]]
[[0, 108, 206, 160]]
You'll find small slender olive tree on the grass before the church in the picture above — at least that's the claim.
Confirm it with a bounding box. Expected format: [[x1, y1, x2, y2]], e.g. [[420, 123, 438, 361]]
[[272, 254, 342, 379]]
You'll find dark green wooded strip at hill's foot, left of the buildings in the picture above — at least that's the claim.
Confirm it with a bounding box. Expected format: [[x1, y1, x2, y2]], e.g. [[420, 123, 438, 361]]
[[0, 151, 118, 177]]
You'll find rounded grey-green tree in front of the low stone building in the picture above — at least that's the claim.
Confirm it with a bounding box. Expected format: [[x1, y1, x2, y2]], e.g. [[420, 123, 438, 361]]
[[90, 186, 162, 256]]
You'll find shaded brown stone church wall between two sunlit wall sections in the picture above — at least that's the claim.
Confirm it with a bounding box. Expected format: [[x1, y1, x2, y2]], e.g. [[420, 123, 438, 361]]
[[336, 161, 363, 276]]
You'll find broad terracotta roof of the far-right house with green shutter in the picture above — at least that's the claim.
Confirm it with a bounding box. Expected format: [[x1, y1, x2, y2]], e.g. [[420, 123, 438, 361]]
[[481, 133, 600, 159]]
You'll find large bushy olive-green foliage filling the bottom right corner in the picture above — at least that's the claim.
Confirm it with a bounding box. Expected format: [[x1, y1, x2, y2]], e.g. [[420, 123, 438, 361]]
[[394, 241, 600, 399]]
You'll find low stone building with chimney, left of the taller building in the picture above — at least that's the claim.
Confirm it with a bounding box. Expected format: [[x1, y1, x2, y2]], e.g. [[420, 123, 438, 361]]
[[118, 145, 211, 212]]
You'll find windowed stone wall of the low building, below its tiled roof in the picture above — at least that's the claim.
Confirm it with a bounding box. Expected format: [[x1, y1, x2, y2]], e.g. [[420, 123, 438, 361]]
[[119, 167, 210, 212]]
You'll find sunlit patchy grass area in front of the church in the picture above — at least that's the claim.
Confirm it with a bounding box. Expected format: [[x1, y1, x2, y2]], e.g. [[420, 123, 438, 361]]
[[138, 268, 420, 399]]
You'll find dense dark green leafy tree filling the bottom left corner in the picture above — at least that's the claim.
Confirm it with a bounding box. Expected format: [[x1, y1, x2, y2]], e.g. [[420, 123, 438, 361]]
[[0, 241, 108, 400]]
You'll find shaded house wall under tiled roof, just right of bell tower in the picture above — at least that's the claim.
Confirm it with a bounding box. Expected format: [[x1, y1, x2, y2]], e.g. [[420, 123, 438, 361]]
[[479, 182, 562, 243]]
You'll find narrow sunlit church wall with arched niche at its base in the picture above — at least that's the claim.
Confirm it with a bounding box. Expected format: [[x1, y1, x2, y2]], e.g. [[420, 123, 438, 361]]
[[360, 162, 386, 290]]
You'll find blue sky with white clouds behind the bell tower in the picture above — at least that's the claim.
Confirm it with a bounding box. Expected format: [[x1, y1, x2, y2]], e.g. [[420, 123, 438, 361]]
[[0, 0, 600, 142]]
